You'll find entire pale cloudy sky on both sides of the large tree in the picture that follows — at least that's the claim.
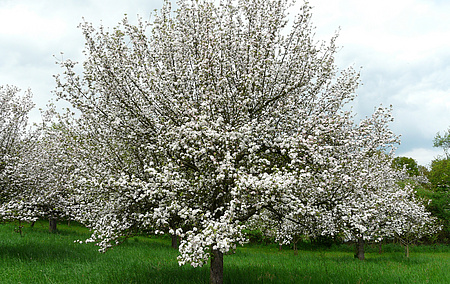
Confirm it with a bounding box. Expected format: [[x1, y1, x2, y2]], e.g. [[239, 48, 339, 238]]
[[0, 0, 450, 166]]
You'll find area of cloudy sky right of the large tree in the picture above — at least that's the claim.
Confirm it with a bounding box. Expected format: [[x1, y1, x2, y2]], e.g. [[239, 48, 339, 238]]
[[311, 0, 450, 164]]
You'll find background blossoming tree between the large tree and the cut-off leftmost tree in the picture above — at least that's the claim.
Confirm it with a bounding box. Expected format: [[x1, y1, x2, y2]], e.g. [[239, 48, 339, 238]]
[[0, 113, 78, 232]]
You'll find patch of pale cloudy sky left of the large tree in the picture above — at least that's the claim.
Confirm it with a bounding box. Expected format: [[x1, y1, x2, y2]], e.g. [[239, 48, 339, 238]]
[[0, 0, 163, 107]]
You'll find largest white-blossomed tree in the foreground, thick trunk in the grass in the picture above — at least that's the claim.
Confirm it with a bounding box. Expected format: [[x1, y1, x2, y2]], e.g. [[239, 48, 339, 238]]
[[51, 0, 432, 283]]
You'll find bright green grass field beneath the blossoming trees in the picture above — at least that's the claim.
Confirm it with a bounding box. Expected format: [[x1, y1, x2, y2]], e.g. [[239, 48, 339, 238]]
[[0, 222, 450, 284]]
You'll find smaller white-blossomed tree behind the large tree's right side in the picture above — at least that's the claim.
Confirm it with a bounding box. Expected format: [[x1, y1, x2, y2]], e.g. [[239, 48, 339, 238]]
[[246, 108, 438, 259]]
